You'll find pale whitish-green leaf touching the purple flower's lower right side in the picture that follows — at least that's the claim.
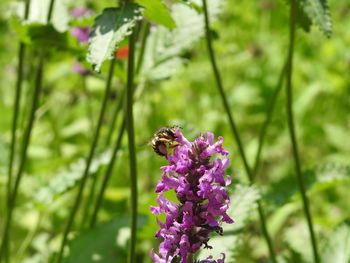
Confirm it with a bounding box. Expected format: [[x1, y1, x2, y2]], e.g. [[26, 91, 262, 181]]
[[198, 185, 260, 263]]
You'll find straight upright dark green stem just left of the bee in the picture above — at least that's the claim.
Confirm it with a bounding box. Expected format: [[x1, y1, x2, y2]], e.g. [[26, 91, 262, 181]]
[[126, 24, 137, 263]]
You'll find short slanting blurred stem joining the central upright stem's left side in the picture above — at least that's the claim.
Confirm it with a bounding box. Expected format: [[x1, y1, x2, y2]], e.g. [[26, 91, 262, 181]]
[[90, 118, 126, 228]]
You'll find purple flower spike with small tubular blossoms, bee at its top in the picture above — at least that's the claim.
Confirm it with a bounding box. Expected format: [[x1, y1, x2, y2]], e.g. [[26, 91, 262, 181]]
[[150, 129, 233, 263]]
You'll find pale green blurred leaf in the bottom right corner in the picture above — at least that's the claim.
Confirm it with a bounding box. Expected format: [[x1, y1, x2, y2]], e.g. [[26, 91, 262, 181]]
[[321, 219, 350, 263]]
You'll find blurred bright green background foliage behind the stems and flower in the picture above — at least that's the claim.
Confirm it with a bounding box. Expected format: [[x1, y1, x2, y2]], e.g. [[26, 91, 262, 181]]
[[0, 0, 350, 263]]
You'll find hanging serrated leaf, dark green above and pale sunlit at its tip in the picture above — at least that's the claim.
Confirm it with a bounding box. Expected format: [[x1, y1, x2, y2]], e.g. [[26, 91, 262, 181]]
[[87, 3, 141, 71]]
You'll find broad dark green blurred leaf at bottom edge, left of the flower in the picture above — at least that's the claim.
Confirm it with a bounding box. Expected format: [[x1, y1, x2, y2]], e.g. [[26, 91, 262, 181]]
[[64, 216, 146, 263]]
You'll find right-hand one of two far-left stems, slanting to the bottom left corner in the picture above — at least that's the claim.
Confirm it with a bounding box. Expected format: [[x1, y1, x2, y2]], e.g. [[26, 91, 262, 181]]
[[0, 53, 45, 260]]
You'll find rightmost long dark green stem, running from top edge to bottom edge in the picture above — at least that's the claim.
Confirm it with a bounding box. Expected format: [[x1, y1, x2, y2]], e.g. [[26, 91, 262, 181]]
[[286, 0, 320, 263]]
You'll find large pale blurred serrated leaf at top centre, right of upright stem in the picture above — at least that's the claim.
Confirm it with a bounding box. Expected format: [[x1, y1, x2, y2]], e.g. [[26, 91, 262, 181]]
[[141, 0, 222, 80]]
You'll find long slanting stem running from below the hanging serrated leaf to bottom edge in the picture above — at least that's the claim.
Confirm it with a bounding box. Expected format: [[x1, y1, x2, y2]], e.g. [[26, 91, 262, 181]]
[[57, 59, 115, 263]]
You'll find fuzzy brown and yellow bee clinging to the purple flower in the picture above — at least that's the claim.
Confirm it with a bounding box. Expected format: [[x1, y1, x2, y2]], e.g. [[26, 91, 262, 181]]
[[151, 126, 177, 156]]
